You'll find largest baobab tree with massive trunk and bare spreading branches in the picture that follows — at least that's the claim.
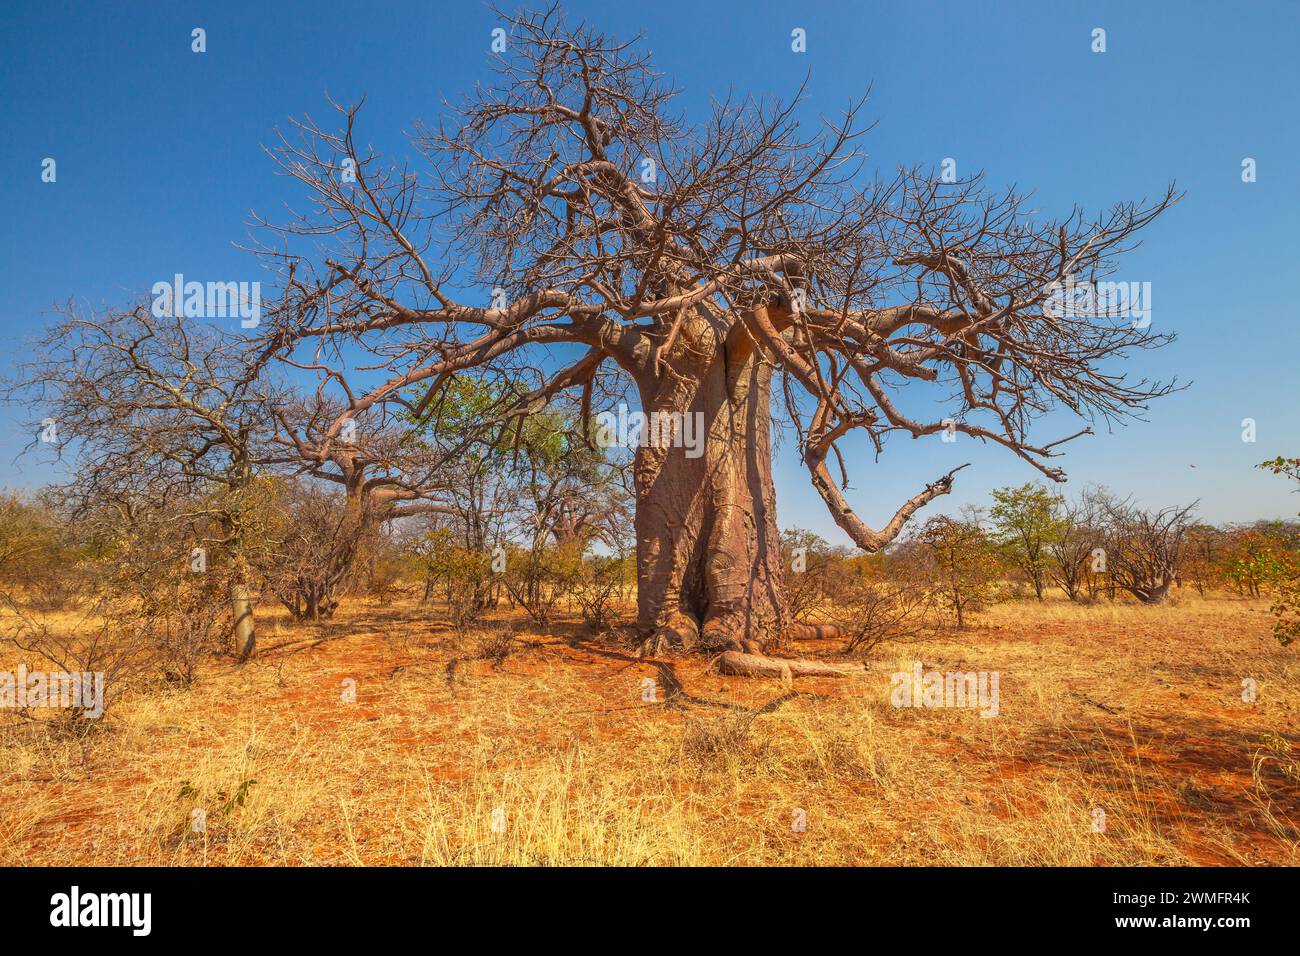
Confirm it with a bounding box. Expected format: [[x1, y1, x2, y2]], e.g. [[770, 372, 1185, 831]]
[[250, 8, 1175, 671]]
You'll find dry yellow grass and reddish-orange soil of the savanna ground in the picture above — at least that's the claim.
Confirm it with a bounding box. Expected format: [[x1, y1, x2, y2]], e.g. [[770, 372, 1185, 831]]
[[0, 589, 1300, 865]]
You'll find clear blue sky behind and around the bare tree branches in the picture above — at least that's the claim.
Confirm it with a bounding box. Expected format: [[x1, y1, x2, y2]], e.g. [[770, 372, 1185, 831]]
[[0, 0, 1300, 544]]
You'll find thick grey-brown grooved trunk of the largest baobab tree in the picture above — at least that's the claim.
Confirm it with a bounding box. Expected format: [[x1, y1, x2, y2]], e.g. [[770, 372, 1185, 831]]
[[636, 319, 789, 650]]
